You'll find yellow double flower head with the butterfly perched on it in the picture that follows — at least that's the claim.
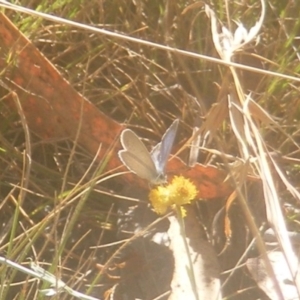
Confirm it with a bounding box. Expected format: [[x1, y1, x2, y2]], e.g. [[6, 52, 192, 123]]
[[149, 176, 197, 215]]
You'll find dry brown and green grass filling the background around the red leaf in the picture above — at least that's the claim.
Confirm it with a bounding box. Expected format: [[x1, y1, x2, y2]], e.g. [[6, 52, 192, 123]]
[[0, 0, 300, 299]]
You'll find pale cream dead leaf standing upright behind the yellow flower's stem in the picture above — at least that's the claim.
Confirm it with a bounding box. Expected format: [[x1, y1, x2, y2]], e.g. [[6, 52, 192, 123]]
[[168, 206, 222, 300]]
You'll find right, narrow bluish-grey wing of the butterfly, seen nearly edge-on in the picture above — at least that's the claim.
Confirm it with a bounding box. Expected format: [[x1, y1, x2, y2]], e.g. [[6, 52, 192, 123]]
[[151, 119, 179, 174]]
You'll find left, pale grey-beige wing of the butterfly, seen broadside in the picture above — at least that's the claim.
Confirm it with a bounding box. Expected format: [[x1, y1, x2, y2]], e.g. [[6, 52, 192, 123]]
[[118, 129, 157, 182]]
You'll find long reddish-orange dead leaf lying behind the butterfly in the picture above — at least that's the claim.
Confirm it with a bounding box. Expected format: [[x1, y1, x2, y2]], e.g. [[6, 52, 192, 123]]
[[0, 14, 232, 199]]
